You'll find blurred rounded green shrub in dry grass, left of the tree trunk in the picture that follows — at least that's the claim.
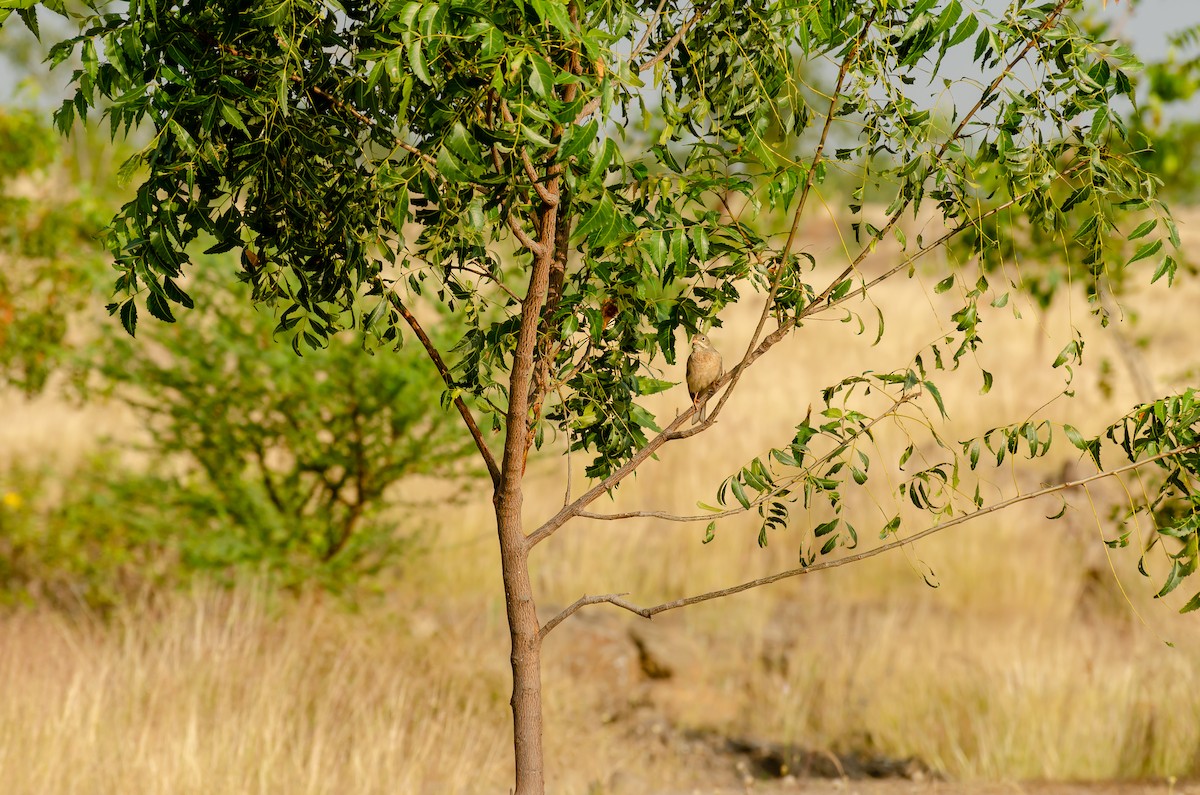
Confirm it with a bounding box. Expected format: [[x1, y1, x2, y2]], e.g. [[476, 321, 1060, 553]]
[[65, 257, 473, 605]]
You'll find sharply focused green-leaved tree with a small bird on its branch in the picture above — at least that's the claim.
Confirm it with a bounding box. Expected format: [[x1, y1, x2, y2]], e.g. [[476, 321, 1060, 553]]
[[9, 0, 1200, 795]]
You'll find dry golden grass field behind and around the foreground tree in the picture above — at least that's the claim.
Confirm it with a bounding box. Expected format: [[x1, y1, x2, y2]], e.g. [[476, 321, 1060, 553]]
[[0, 208, 1200, 795]]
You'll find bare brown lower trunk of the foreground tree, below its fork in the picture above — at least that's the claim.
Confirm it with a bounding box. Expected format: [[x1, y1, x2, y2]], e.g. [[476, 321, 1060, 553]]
[[496, 499, 546, 795]]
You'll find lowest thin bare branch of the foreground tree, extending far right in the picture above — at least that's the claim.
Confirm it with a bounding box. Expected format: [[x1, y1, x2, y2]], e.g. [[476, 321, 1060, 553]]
[[541, 442, 1200, 636]]
